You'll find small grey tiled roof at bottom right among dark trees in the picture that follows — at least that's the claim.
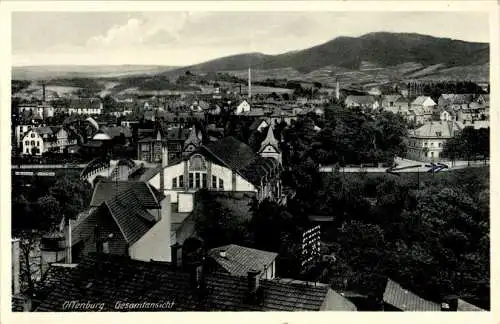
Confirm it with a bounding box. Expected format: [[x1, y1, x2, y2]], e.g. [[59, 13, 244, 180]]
[[384, 279, 441, 312]]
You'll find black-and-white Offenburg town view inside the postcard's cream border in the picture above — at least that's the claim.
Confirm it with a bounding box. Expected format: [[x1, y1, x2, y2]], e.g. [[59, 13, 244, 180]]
[[2, 1, 498, 316]]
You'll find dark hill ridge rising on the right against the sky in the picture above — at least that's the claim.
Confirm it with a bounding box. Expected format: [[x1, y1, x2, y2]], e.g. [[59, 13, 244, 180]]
[[181, 32, 489, 73]]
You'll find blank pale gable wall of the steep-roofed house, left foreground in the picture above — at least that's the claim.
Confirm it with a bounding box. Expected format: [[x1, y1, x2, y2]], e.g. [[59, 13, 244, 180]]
[[129, 196, 172, 262]]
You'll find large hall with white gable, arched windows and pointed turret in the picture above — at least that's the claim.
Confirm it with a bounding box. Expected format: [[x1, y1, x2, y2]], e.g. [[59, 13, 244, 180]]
[[142, 132, 282, 212]]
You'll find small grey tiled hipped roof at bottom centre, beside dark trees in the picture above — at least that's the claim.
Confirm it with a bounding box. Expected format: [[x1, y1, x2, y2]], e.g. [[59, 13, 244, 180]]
[[208, 244, 278, 276]]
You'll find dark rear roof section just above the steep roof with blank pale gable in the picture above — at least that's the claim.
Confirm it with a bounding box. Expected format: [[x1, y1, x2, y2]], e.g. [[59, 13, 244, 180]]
[[90, 180, 164, 208]]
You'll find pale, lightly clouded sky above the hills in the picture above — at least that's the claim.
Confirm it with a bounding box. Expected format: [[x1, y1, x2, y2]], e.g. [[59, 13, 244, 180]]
[[12, 11, 489, 66]]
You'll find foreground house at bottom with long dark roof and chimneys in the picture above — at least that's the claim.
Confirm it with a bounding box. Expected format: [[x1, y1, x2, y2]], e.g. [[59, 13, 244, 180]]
[[34, 254, 356, 312]]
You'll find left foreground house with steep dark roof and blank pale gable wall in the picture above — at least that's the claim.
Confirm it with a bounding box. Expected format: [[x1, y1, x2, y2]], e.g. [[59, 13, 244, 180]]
[[71, 180, 172, 261]]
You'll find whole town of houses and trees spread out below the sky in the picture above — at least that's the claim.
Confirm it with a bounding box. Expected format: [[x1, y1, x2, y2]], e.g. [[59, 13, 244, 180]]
[[11, 11, 490, 312]]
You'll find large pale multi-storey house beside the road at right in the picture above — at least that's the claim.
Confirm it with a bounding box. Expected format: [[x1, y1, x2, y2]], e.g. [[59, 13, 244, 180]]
[[407, 121, 463, 161]]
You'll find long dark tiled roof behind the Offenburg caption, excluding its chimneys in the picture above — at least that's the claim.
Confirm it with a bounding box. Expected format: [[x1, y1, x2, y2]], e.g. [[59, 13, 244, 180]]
[[36, 254, 353, 311]]
